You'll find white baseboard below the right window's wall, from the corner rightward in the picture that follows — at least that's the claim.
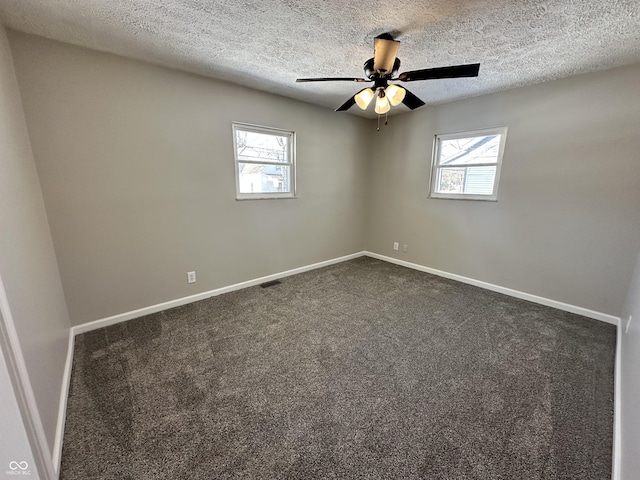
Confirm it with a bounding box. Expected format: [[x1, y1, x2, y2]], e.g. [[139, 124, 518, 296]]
[[364, 252, 620, 325]]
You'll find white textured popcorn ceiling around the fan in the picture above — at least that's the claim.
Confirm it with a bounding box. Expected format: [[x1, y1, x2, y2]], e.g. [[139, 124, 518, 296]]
[[0, 0, 640, 116]]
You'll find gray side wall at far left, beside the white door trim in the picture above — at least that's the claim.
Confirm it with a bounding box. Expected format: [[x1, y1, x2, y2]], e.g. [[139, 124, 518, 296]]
[[0, 25, 69, 458]]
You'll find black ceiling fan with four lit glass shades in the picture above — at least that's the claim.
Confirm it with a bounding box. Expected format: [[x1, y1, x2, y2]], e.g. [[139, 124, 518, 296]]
[[296, 33, 480, 115]]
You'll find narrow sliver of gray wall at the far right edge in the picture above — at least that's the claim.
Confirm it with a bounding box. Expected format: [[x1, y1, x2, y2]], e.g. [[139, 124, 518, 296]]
[[620, 255, 640, 480]]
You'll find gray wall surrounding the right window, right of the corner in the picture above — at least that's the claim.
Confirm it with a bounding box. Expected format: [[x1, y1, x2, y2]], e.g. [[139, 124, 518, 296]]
[[366, 65, 640, 316]]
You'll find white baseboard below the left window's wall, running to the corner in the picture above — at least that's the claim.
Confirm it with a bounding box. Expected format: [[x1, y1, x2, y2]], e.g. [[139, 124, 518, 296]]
[[71, 252, 365, 336]]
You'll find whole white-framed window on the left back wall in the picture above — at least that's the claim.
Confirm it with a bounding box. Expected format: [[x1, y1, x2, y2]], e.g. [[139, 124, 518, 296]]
[[233, 122, 296, 200]]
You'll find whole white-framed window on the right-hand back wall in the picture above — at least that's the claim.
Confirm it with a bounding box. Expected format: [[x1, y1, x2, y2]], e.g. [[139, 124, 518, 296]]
[[429, 127, 507, 200]]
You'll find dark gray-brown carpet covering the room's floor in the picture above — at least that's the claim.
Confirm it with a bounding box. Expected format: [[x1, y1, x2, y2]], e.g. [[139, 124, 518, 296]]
[[61, 257, 616, 480]]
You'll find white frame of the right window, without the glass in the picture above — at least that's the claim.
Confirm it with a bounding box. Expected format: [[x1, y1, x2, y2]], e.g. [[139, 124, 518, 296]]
[[429, 127, 507, 202]]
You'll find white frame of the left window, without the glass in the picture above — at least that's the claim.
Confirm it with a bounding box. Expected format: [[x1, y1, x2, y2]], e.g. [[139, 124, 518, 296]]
[[231, 122, 296, 200]]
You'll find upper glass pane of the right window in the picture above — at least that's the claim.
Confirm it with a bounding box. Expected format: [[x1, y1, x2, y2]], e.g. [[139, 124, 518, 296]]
[[438, 134, 500, 165]]
